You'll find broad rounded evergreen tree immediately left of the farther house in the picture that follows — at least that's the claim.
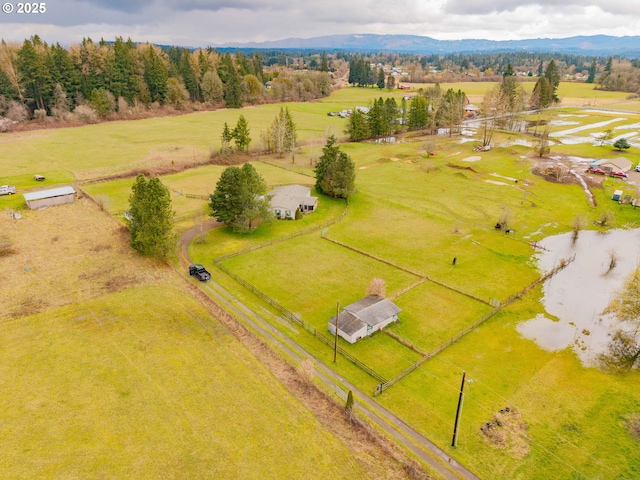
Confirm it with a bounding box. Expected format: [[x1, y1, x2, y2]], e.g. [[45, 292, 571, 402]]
[[209, 163, 273, 232]]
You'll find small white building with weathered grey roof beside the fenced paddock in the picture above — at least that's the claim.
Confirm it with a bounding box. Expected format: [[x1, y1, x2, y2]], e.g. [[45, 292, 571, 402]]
[[329, 295, 402, 343]]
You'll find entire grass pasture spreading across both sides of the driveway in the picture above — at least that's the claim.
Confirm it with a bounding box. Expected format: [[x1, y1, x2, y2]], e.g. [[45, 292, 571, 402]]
[[0, 84, 640, 480]]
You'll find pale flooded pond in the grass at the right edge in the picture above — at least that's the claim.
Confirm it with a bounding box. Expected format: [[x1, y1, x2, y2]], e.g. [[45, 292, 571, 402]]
[[517, 229, 640, 366]]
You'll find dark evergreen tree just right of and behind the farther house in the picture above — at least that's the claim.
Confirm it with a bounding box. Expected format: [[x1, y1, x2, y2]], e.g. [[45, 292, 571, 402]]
[[314, 135, 356, 198]]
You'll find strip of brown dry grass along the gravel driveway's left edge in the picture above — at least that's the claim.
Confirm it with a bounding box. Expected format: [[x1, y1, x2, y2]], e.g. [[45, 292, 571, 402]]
[[189, 284, 432, 480]]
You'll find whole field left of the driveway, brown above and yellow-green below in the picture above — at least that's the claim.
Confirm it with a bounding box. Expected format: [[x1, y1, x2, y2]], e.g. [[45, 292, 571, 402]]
[[0, 198, 420, 479]]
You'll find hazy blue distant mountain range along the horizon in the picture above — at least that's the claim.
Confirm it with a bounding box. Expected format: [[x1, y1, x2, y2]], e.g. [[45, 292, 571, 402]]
[[217, 34, 640, 58]]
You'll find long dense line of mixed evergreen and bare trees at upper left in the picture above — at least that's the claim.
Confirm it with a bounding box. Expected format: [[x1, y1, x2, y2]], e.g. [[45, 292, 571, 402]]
[[0, 35, 331, 125]]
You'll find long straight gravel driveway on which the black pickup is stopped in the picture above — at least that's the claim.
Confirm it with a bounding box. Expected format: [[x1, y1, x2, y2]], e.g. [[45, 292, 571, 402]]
[[180, 219, 480, 480]]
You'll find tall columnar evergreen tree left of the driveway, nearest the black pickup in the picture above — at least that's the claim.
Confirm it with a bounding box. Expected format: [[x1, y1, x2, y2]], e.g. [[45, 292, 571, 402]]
[[129, 175, 177, 260]]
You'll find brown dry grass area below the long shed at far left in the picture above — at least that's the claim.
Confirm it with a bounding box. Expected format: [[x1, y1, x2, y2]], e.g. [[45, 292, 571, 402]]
[[0, 199, 167, 318]]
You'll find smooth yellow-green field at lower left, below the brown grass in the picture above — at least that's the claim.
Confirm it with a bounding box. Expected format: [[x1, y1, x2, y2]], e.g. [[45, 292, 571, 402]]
[[0, 286, 367, 479]]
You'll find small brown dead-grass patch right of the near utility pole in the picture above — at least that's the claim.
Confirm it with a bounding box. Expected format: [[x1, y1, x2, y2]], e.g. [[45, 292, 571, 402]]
[[480, 409, 530, 458]]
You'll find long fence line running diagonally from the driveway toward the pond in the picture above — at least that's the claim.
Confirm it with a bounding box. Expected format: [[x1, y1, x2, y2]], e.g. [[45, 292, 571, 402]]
[[374, 255, 576, 395]]
